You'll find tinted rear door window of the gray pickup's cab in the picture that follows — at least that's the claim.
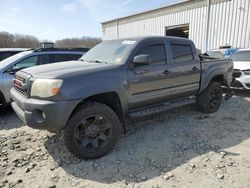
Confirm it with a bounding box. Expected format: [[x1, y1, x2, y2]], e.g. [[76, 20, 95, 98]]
[[170, 44, 194, 63]]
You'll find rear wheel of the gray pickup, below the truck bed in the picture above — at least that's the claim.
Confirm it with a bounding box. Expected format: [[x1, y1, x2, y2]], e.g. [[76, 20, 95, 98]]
[[197, 81, 222, 114]]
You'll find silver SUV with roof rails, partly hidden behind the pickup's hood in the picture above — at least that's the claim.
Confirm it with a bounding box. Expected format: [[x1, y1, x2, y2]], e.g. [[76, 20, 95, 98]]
[[0, 48, 88, 106]]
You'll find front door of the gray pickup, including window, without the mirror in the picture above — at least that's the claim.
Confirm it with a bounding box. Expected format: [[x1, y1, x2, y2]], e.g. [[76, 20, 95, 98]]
[[128, 40, 171, 109]]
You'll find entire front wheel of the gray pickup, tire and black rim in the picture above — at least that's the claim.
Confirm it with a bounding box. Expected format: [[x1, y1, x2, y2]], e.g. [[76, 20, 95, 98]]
[[64, 102, 121, 159]]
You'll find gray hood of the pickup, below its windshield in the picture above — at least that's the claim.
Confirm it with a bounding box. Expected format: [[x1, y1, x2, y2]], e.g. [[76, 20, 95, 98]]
[[22, 61, 112, 78]]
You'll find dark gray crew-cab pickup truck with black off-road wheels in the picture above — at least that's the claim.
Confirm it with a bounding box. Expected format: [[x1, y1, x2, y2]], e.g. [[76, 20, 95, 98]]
[[11, 37, 233, 159]]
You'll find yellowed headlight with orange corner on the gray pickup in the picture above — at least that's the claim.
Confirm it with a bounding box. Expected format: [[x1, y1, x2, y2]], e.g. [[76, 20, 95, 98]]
[[30, 78, 63, 98]]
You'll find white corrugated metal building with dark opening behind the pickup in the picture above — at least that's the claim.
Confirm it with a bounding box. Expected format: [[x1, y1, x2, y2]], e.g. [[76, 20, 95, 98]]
[[102, 0, 250, 51]]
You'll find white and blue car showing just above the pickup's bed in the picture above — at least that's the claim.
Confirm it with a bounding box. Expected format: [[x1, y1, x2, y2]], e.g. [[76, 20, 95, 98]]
[[206, 47, 239, 59]]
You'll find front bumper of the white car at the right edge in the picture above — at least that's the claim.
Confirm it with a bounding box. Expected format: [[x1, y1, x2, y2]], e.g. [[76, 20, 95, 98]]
[[231, 71, 250, 90]]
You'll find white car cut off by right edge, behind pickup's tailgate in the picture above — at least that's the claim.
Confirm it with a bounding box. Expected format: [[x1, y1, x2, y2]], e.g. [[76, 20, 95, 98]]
[[231, 49, 250, 90]]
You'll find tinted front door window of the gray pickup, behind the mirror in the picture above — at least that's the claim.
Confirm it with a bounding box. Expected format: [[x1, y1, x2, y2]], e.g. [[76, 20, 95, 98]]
[[136, 44, 166, 65]]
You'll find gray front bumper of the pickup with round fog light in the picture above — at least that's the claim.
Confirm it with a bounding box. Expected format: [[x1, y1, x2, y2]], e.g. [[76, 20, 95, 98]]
[[11, 89, 81, 131]]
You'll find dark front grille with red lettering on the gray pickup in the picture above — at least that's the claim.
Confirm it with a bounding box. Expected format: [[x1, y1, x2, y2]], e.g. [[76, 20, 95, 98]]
[[14, 75, 29, 98]]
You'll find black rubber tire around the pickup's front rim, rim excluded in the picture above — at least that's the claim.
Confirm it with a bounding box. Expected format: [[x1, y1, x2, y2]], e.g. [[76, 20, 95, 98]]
[[64, 102, 122, 159]]
